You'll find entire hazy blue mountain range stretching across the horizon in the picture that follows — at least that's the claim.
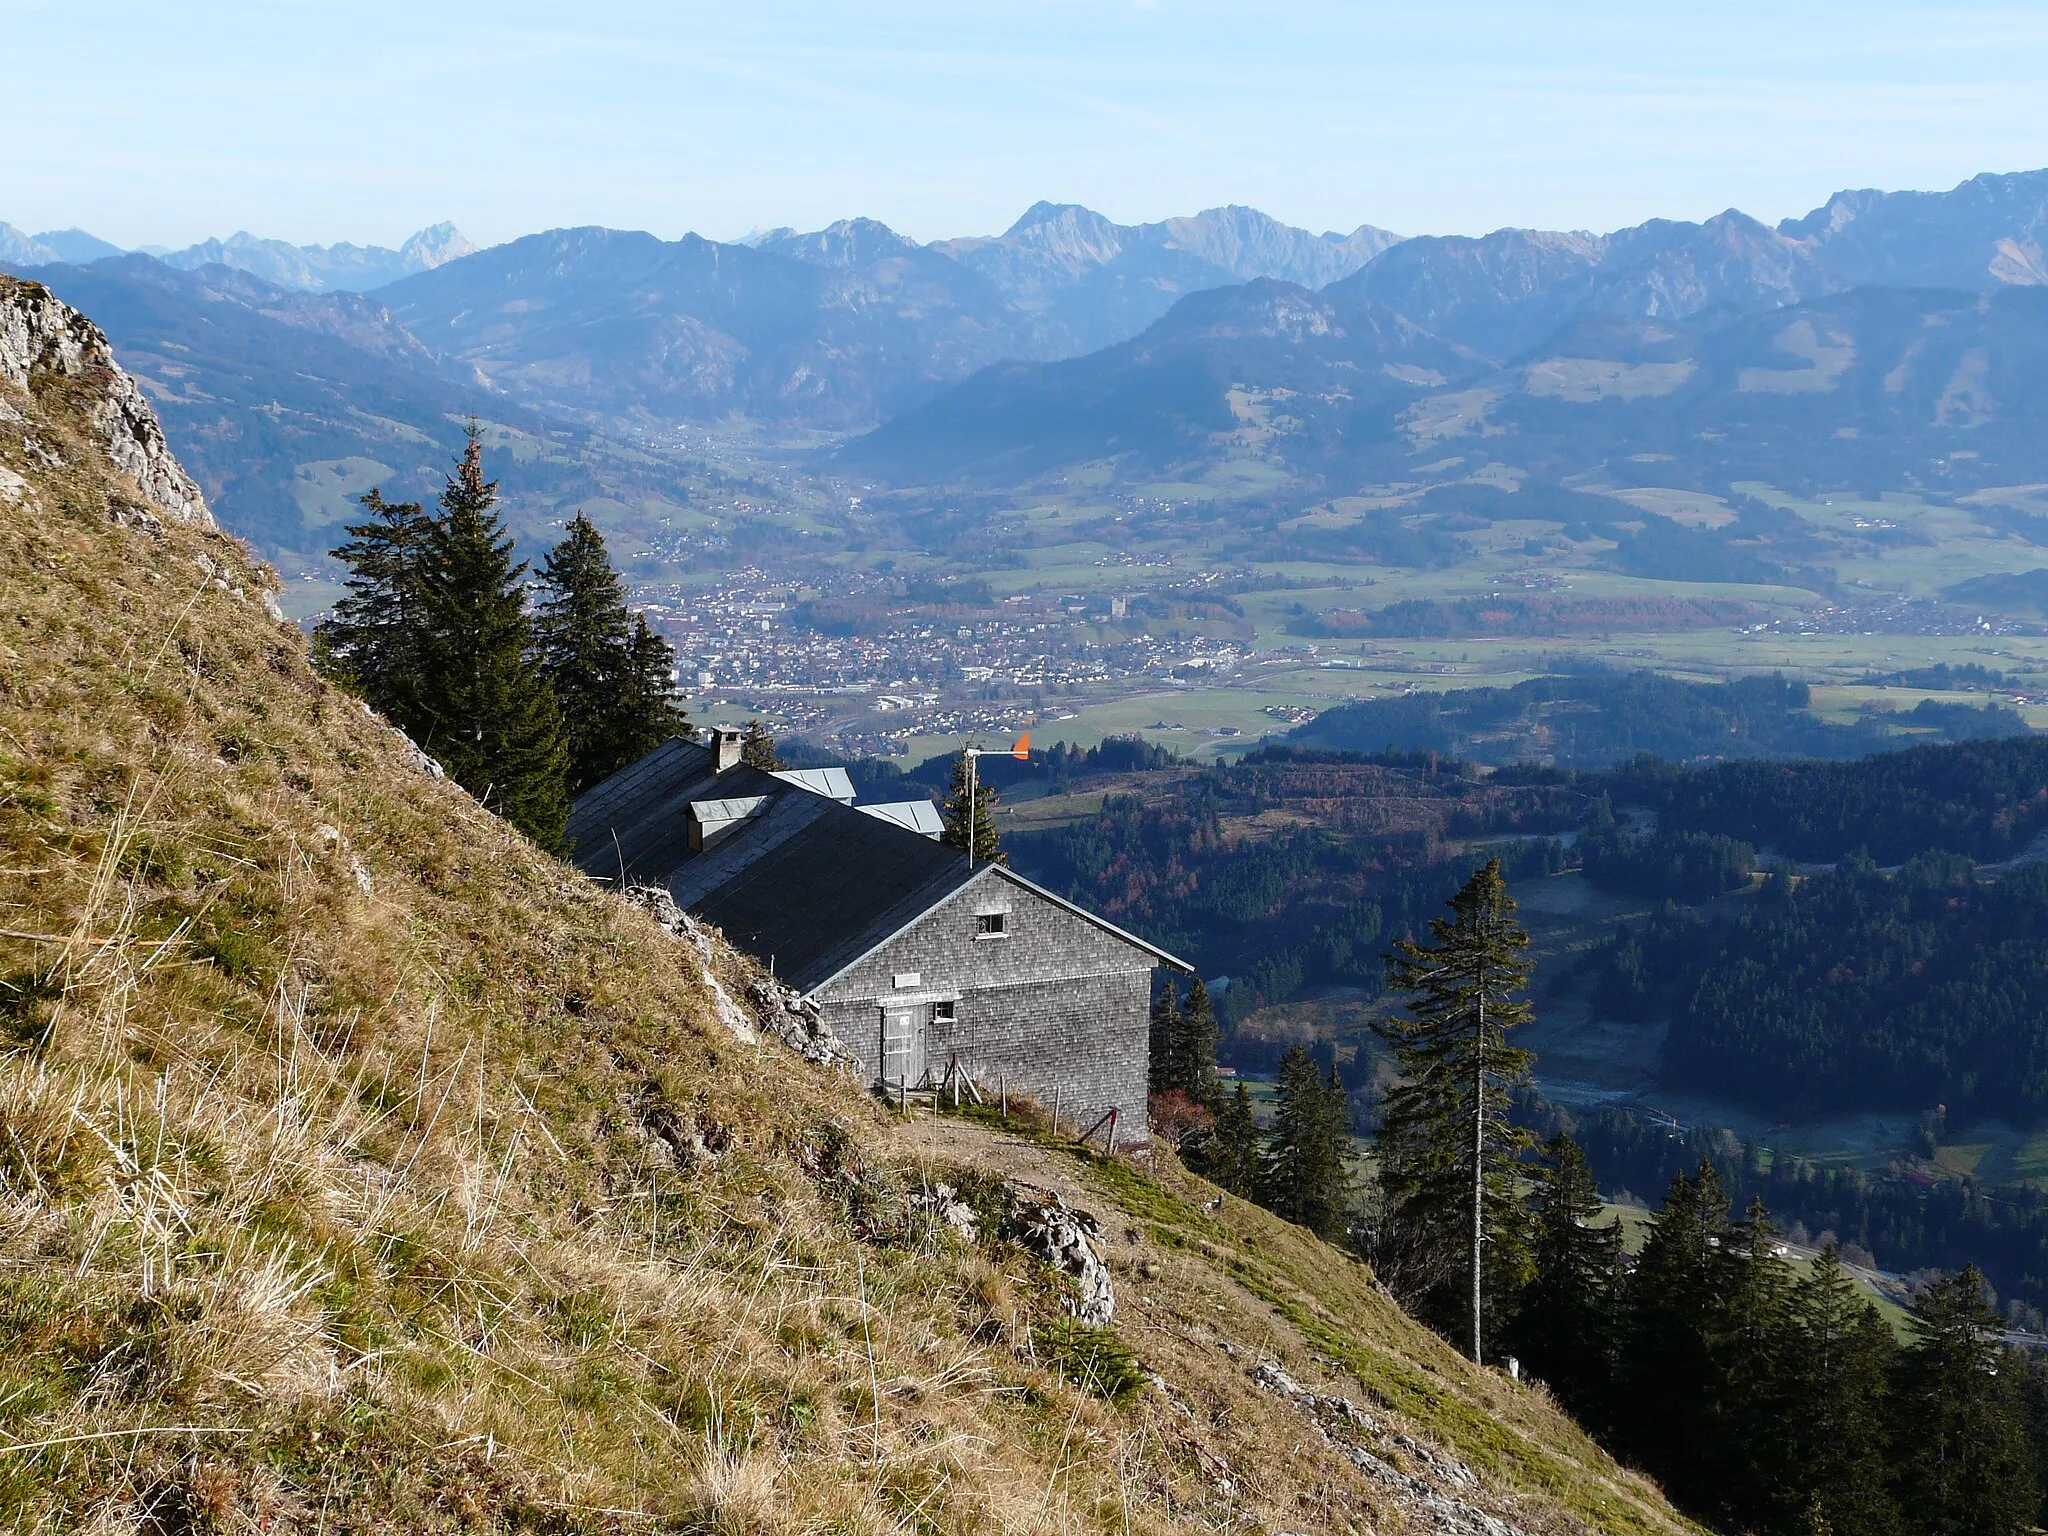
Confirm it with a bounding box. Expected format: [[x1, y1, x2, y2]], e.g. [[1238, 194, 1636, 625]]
[[12, 172, 2048, 551]]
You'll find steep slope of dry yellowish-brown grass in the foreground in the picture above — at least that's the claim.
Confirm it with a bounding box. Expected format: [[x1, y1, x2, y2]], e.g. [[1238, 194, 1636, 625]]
[[0, 283, 1683, 1536]]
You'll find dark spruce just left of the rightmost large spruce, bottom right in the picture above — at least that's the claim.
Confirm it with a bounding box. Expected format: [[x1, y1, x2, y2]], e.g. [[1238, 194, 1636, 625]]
[[1784, 1243, 1901, 1536]]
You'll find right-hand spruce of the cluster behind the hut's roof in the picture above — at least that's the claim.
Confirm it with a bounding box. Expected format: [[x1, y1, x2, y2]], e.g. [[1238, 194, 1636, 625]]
[[535, 512, 684, 795]]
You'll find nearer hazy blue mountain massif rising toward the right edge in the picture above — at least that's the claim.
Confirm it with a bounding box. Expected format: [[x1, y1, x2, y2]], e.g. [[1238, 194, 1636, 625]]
[[842, 172, 2048, 494]]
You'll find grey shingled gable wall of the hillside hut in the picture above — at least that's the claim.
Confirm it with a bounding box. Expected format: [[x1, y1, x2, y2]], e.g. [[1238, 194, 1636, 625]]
[[815, 870, 1153, 1143]]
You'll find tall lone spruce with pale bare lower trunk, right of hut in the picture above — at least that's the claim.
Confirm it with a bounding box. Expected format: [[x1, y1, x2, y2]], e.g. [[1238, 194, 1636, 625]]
[[1374, 858, 1532, 1360]]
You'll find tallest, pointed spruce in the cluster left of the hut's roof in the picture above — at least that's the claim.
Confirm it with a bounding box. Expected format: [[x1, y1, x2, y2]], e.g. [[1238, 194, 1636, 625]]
[[420, 426, 569, 850]]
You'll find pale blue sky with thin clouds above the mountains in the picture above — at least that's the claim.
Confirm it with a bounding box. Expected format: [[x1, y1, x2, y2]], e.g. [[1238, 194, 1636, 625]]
[[0, 0, 2048, 244]]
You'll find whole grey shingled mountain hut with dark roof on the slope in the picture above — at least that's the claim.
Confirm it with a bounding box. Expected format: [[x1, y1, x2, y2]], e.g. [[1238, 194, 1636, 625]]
[[569, 729, 1186, 1141]]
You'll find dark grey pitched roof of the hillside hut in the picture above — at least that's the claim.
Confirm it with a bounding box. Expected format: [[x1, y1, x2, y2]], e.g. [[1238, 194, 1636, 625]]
[[569, 739, 1180, 991]]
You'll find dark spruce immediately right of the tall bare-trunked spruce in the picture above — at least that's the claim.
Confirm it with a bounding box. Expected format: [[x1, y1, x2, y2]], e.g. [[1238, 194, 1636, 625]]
[[1507, 1130, 1622, 1427]]
